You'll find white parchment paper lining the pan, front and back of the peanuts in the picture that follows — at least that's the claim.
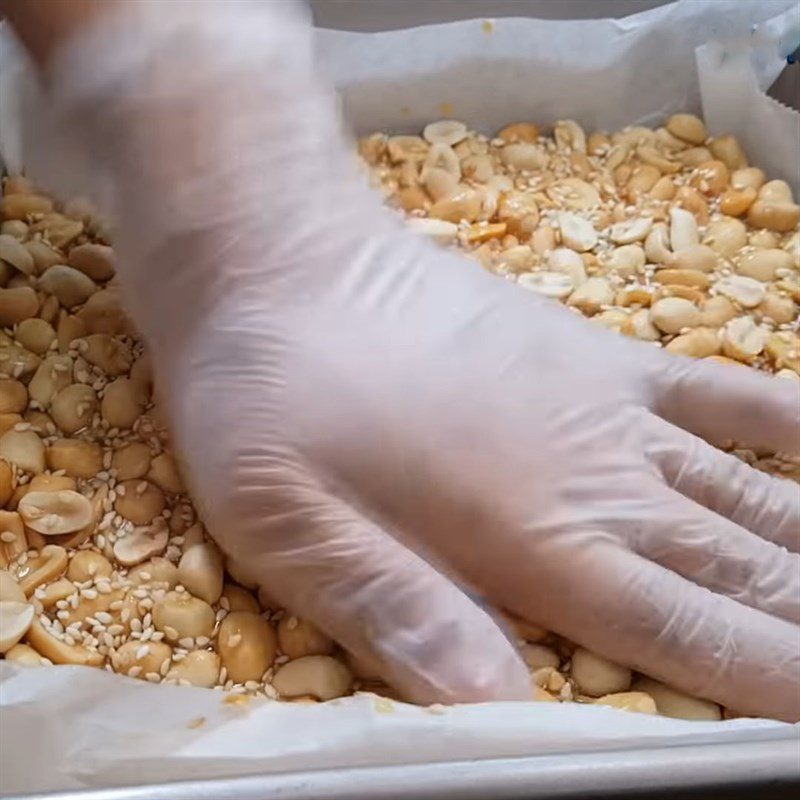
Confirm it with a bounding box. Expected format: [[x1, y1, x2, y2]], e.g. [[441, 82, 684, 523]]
[[0, 0, 800, 794]]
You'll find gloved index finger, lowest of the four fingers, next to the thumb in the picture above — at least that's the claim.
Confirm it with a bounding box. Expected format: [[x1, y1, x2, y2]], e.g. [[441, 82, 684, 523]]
[[494, 536, 800, 721]]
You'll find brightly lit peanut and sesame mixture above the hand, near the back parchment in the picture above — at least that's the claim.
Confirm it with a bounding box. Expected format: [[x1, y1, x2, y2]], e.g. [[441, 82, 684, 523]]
[[359, 114, 800, 394]]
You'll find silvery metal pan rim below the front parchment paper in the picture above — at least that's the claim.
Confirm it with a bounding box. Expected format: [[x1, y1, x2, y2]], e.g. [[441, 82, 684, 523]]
[[7, 729, 800, 800]]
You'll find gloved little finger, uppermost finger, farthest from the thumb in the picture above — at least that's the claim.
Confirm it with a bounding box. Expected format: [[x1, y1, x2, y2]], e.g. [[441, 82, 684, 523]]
[[653, 357, 800, 455]]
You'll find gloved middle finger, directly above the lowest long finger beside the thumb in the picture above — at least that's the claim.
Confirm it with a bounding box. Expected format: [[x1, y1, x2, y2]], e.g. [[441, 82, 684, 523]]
[[631, 484, 800, 623]]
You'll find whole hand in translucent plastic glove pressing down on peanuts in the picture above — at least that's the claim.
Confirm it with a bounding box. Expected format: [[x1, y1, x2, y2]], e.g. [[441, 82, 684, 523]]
[[45, 2, 800, 719]]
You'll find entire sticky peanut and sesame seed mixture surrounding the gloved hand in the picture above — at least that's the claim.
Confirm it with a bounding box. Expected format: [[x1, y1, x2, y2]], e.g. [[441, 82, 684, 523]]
[[0, 114, 800, 719]]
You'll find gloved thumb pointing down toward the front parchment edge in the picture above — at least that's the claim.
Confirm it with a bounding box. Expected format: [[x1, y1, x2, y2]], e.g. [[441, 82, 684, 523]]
[[223, 490, 531, 704]]
